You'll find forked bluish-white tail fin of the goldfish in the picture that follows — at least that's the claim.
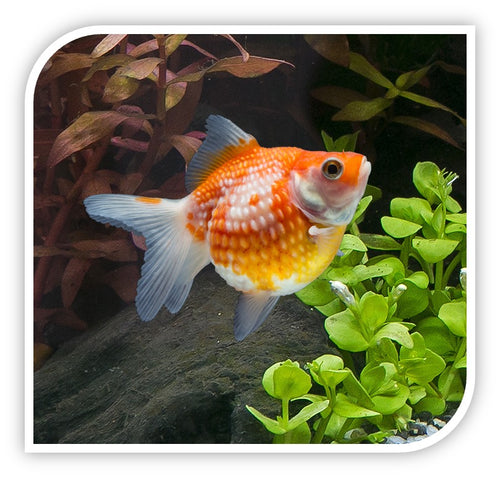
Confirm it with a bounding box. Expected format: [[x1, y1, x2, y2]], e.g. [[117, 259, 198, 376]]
[[84, 194, 210, 321]]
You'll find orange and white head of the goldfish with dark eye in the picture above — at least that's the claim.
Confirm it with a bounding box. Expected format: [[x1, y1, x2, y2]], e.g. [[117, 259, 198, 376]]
[[289, 151, 371, 226]]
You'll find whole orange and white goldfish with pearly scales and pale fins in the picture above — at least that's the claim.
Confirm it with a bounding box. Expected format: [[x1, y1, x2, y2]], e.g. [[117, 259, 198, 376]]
[[84, 115, 371, 341]]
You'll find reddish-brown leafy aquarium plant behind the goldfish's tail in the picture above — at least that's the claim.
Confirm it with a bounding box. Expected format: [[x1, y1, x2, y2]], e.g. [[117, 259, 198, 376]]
[[34, 34, 292, 366]]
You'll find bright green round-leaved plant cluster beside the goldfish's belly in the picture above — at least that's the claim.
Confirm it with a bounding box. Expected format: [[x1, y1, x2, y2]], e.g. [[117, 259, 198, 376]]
[[249, 162, 467, 443]]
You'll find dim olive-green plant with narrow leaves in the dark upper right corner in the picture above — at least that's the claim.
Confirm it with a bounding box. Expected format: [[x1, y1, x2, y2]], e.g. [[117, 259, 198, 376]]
[[305, 35, 465, 149]]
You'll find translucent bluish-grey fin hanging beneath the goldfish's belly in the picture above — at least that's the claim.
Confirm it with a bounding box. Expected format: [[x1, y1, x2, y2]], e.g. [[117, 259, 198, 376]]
[[234, 292, 279, 341]]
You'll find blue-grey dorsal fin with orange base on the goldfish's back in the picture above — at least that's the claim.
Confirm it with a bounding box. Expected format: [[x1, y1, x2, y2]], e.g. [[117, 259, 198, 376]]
[[186, 115, 259, 193]]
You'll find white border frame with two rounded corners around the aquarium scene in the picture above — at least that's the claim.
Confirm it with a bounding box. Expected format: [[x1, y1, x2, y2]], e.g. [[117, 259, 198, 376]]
[[24, 25, 476, 454]]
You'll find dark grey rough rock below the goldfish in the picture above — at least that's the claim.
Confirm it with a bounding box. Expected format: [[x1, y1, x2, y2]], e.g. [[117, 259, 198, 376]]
[[34, 267, 334, 443]]
